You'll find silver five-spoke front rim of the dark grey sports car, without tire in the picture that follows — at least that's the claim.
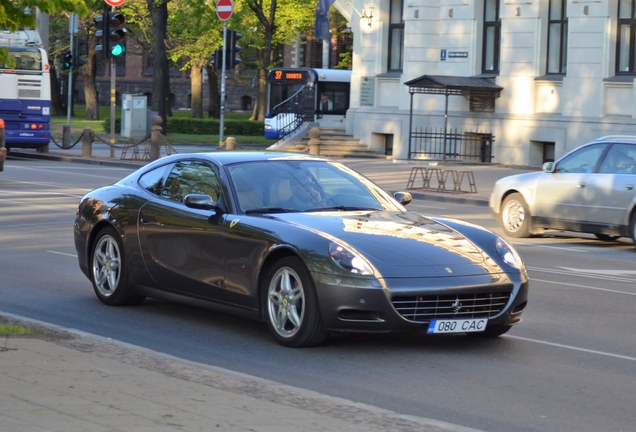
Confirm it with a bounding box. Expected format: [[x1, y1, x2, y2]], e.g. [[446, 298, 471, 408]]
[[267, 267, 305, 338]]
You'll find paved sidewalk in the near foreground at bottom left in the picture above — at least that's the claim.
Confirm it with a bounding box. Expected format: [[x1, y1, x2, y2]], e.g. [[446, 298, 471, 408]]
[[0, 312, 482, 432]]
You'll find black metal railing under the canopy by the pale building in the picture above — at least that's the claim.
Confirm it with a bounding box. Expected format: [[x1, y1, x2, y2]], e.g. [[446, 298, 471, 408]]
[[409, 128, 495, 163]]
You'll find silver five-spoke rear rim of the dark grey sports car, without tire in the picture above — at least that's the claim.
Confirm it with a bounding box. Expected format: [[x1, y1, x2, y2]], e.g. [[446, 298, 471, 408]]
[[93, 235, 121, 297]]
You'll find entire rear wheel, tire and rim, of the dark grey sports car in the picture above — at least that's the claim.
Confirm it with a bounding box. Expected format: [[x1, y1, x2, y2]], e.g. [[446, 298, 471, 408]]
[[91, 227, 144, 306]]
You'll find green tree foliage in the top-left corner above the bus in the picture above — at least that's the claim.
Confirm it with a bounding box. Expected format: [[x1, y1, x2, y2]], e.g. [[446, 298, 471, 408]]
[[0, 0, 88, 65]]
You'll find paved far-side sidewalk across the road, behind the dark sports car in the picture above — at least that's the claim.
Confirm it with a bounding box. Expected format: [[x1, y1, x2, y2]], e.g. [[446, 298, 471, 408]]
[[11, 143, 539, 206]]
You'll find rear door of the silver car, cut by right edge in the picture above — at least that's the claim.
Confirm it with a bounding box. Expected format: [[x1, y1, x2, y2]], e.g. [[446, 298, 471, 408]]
[[586, 144, 636, 226]]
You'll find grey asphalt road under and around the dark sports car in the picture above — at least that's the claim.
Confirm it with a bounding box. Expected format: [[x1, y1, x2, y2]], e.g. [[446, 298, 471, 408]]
[[0, 160, 636, 431]]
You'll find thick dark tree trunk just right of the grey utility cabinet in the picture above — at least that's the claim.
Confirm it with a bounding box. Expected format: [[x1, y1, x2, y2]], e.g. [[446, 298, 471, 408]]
[[146, 0, 170, 135]]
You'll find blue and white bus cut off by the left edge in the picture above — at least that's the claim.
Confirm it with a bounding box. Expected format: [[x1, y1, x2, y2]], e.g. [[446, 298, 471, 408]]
[[0, 30, 51, 149]]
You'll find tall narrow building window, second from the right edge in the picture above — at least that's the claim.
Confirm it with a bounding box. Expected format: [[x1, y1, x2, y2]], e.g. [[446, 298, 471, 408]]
[[547, 0, 568, 74]]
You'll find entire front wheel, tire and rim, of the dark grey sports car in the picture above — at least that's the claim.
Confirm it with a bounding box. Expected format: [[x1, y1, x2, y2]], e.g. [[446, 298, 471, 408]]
[[261, 257, 327, 347]]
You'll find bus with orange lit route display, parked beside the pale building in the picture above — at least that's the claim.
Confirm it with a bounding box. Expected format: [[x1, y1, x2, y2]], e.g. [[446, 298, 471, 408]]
[[265, 68, 351, 139]]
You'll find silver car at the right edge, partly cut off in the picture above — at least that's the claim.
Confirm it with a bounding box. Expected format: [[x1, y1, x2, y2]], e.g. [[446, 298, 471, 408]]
[[490, 136, 636, 242]]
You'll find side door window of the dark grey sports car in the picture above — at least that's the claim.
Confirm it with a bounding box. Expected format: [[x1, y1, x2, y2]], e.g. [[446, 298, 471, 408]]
[[161, 160, 221, 202]]
